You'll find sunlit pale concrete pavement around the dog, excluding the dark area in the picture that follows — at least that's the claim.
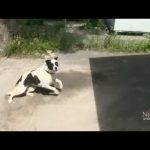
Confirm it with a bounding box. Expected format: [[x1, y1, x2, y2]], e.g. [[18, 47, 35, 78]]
[[0, 51, 100, 131]]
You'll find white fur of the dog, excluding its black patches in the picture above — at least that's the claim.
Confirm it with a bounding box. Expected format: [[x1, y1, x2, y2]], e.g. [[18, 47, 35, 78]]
[[7, 57, 63, 103]]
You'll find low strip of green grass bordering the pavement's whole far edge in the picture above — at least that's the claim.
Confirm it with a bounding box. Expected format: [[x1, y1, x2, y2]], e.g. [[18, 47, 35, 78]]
[[3, 33, 150, 57]]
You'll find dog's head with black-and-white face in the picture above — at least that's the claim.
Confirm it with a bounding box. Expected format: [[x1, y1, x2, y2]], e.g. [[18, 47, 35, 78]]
[[45, 50, 58, 73]]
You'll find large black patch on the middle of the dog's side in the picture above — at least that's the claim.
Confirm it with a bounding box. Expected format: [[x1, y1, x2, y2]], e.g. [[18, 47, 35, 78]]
[[24, 73, 40, 86]]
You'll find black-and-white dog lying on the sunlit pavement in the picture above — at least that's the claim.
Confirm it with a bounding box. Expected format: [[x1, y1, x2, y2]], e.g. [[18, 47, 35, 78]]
[[6, 52, 63, 103]]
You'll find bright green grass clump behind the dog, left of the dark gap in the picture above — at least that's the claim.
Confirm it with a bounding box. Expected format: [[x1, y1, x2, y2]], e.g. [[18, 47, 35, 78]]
[[3, 37, 59, 57]]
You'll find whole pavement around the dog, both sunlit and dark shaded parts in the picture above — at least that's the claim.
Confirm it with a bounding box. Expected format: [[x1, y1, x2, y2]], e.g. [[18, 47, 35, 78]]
[[0, 51, 150, 131]]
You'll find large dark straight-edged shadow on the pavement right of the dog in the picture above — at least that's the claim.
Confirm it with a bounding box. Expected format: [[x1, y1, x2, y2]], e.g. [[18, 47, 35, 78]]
[[90, 55, 150, 131]]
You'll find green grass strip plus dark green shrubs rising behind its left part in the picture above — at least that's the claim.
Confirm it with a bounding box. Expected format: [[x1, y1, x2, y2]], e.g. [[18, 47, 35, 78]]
[[1, 20, 150, 57]]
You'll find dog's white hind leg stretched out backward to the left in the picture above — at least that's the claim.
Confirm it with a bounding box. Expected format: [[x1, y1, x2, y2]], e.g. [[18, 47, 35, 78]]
[[8, 85, 27, 103]]
